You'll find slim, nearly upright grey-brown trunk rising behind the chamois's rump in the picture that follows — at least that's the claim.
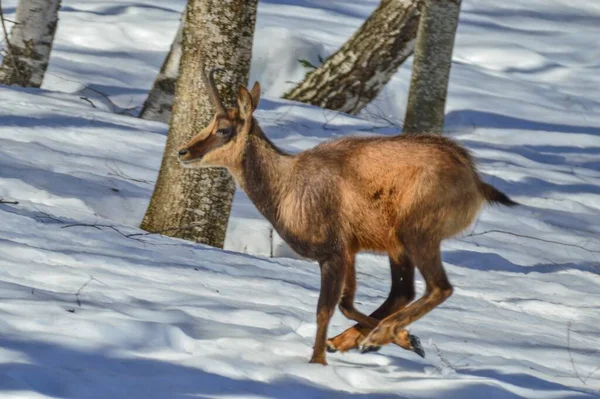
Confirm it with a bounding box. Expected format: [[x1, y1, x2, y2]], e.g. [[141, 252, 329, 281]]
[[403, 0, 460, 134]]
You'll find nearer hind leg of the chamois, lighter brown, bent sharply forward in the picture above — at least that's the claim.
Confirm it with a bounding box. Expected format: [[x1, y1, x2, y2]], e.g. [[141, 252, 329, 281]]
[[359, 239, 452, 350]]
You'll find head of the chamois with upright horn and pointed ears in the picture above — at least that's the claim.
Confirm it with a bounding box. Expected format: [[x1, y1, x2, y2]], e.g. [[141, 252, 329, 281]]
[[178, 69, 260, 168]]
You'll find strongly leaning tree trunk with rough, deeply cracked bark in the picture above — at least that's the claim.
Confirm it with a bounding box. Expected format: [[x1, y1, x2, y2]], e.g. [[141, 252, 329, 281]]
[[284, 0, 419, 114]]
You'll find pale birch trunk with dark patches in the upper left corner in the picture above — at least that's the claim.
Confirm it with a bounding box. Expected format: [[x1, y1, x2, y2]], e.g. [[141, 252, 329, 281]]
[[0, 0, 60, 87]]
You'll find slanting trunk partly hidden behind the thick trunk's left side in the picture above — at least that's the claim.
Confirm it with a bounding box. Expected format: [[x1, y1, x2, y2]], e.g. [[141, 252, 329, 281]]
[[140, 10, 187, 123]]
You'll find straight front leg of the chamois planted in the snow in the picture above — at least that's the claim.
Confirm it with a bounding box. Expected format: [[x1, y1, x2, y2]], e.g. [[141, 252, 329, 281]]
[[310, 255, 346, 365]]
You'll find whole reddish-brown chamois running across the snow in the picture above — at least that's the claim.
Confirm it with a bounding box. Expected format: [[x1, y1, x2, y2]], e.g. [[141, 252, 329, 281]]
[[178, 69, 516, 364]]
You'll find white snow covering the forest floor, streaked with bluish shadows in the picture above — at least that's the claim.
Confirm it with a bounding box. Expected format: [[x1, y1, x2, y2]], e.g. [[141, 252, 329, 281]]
[[0, 0, 600, 399]]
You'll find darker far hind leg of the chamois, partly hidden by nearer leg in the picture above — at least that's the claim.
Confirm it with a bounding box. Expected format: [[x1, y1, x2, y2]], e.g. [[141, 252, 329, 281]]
[[327, 252, 423, 356]]
